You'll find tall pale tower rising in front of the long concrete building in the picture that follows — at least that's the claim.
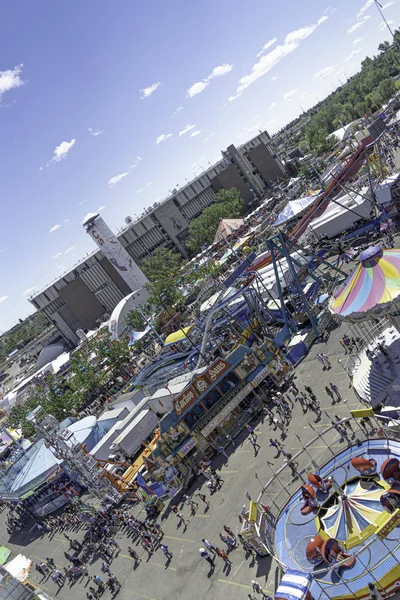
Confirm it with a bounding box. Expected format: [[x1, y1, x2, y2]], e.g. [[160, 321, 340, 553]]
[[82, 214, 149, 292]]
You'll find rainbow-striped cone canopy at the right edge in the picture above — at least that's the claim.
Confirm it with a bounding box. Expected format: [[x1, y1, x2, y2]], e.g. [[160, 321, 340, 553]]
[[330, 246, 400, 317]]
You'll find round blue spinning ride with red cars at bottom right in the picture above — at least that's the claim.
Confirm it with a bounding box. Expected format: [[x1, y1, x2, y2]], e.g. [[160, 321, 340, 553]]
[[270, 438, 400, 600]]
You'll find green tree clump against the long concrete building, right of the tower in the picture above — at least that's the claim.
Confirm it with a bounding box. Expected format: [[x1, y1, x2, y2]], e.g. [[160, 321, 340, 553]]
[[187, 188, 243, 252]]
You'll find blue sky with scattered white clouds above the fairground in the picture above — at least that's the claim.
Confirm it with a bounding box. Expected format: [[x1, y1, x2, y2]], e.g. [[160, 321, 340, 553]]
[[0, 0, 400, 331]]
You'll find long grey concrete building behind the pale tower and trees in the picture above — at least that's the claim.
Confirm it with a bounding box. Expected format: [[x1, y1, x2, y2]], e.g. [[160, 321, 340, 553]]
[[30, 131, 285, 346]]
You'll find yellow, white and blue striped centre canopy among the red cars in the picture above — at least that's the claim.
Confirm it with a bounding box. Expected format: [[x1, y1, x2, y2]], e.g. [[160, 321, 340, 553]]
[[321, 481, 384, 542]]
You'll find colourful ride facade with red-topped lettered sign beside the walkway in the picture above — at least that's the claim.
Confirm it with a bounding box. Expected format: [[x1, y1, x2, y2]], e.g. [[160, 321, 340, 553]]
[[158, 342, 292, 470]]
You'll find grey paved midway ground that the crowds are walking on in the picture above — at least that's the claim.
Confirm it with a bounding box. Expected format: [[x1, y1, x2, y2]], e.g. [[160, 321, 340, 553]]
[[0, 316, 368, 600]]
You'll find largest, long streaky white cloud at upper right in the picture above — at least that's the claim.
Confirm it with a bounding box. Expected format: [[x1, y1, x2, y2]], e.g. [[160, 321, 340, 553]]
[[229, 15, 329, 101]]
